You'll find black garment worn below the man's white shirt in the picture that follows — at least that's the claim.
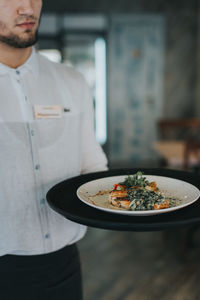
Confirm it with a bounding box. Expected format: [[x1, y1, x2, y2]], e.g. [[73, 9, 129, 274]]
[[0, 245, 82, 300]]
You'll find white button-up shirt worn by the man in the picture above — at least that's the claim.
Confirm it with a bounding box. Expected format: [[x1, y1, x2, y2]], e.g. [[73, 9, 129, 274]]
[[0, 49, 107, 255]]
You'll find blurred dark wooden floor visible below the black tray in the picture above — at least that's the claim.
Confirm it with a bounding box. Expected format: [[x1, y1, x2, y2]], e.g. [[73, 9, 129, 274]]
[[78, 228, 200, 300]]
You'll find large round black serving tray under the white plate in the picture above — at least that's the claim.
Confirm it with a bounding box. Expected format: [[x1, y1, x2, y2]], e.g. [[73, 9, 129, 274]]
[[47, 168, 200, 231]]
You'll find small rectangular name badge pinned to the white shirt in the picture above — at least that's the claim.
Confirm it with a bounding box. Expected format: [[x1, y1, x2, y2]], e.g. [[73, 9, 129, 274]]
[[34, 105, 62, 119]]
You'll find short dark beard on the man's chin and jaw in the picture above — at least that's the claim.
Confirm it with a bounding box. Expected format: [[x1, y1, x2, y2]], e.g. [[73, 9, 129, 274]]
[[0, 29, 38, 48]]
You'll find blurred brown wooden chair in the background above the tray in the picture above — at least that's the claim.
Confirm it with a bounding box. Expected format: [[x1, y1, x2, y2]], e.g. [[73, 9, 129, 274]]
[[155, 118, 200, 170]]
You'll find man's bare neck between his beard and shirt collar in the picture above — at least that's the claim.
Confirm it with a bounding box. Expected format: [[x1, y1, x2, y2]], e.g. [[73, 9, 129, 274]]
[[0, 43, 32, 69]]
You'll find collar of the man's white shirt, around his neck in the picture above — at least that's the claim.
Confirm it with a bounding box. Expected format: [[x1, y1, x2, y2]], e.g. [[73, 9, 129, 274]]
[[0, 47, 39, 75]]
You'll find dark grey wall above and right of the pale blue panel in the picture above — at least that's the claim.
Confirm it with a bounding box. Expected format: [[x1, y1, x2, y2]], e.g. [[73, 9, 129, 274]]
[[41, 0, 200, 118]]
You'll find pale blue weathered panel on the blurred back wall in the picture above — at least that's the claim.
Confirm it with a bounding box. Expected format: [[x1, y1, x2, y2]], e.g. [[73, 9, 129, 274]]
[[108, 14, 165, 165]]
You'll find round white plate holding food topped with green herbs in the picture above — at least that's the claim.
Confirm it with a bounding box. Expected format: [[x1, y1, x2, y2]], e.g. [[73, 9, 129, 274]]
[[77, 172, 200, 215]]
